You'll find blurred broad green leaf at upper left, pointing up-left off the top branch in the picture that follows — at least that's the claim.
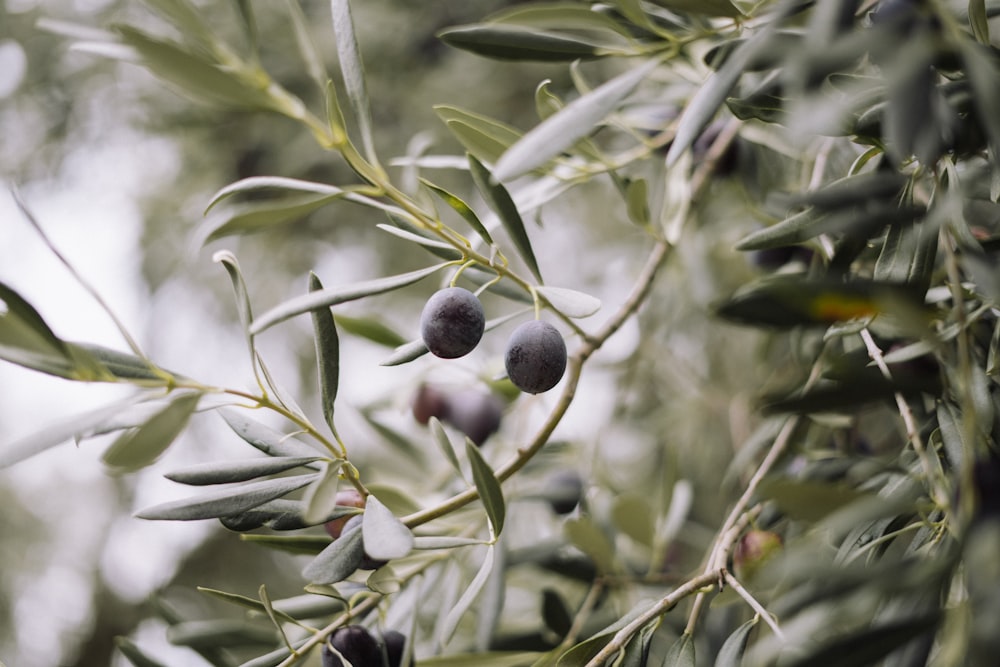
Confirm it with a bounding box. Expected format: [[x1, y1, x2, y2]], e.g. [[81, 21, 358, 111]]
[[116, 25, 274, 110]]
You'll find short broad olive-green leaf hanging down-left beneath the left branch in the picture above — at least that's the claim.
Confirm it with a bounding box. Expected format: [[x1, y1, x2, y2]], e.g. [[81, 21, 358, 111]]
[[101, 393, 201, 472]]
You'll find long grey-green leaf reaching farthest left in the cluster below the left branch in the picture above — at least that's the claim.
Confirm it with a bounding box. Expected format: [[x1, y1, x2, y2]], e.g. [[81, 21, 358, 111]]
[[136, 473, 319, 521]]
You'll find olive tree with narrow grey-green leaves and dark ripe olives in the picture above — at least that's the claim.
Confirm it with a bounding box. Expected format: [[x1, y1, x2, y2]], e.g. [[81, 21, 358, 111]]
[[0, 0, 1000, 667]]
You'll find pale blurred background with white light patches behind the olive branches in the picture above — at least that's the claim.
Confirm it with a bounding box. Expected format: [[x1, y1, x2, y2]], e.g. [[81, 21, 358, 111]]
[[0, 0, 772, 667]]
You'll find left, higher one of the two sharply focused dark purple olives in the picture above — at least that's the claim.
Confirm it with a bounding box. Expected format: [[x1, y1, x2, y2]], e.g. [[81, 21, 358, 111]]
[[420, 287, 486, 359]]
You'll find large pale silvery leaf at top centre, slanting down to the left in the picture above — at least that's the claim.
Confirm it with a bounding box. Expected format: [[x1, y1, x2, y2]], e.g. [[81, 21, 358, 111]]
[[493, 60, 660, 182]]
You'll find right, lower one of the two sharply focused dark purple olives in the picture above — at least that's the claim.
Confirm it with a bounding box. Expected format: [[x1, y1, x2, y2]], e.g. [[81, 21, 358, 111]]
[[504, 320, 566, 394]]
